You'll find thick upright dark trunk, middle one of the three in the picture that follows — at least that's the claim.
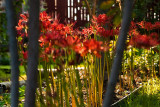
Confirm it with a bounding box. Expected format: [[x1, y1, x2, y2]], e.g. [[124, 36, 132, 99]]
[[24, 0, 40, 107]]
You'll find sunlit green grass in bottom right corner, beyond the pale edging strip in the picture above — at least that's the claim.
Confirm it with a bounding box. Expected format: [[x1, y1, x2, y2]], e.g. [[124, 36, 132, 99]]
[[118, 79, 160, 107]]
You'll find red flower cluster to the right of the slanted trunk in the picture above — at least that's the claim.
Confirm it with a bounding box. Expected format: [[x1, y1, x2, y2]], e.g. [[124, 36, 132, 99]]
[[129, 21, 160, 49]]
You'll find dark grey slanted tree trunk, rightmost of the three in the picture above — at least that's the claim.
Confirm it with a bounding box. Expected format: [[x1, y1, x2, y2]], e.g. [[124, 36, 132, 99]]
[[103, 0, 133, 107]]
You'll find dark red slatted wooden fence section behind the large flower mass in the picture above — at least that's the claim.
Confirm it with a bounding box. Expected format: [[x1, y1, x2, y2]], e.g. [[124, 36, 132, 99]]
[[45, 0, 90, 27]]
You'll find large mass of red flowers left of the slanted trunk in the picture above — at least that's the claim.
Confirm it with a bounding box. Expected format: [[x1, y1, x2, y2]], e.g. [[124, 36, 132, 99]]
[[16, 11, 109, 61]]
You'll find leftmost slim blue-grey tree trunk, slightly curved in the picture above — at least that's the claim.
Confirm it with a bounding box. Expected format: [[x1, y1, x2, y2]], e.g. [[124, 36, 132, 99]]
[[6, 0, 19, 107]]
